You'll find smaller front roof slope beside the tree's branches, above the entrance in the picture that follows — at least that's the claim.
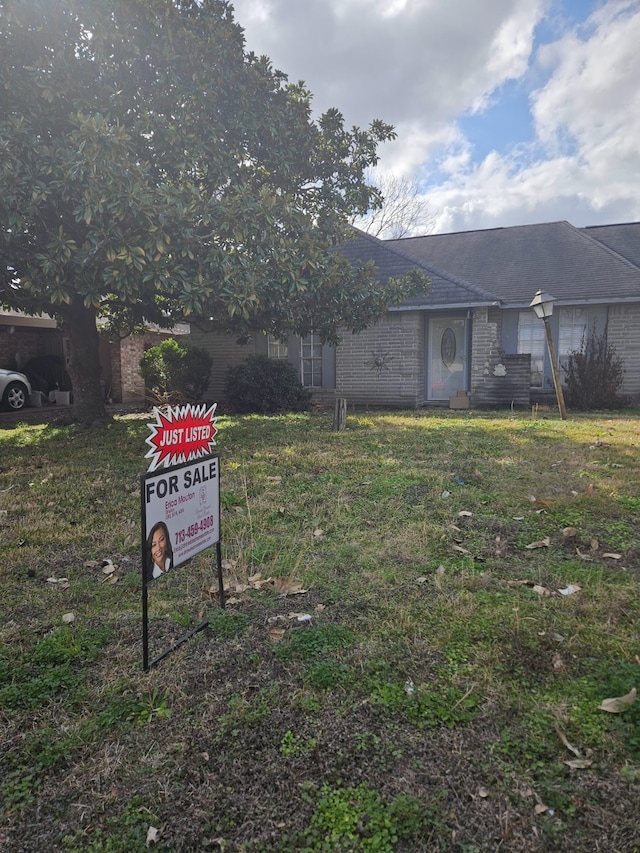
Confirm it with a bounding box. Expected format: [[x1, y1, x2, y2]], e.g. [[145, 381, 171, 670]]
[[338, 229, 496, 309]]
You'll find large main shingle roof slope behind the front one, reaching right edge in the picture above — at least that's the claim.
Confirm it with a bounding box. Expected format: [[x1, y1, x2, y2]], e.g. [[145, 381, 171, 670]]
[[384, 222, 640, 307]]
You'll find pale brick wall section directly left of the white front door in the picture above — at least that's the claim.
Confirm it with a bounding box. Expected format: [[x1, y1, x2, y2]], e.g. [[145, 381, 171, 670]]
[[336, 311, 425, 408]]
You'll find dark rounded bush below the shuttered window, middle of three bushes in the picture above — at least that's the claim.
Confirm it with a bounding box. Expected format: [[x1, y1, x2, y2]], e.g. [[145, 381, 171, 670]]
[[225, 355, 311, 415]]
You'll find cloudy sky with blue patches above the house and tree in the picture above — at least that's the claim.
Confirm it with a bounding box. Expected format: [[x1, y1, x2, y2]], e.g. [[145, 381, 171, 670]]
[[233, 0, 640, 233]]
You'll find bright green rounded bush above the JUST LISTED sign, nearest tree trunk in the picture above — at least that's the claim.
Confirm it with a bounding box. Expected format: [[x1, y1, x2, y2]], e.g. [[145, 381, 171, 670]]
[[140, 338, 213, 406]]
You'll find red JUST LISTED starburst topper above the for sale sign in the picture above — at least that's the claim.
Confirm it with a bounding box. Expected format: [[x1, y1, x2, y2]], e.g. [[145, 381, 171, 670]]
[[145, 403, 218, 471]]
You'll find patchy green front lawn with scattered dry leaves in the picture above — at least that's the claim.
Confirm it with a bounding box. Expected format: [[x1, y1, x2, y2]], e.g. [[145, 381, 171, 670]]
[[0, 411, 640, 853]]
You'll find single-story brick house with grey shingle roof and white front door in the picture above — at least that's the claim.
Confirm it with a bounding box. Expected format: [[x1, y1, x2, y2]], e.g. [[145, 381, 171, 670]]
[[191, 222, 640, 408]]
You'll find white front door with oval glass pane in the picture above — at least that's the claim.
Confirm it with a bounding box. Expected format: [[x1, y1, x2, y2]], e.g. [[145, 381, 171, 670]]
[[427, 317, 468, 400]]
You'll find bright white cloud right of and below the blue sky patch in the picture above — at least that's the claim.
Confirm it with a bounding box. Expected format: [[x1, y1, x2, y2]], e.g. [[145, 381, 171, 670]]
[[410, 0, 640, 231]]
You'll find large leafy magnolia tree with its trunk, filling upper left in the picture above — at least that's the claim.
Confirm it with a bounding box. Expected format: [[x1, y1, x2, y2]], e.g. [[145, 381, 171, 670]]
[[0, 0, 430, 421]]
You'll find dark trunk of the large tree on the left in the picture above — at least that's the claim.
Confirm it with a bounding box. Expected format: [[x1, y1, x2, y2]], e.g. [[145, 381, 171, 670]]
[[58, 296, 108, 424]]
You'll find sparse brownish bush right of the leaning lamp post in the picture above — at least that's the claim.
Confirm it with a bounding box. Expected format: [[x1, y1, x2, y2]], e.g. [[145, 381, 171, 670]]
[[565, 330, 628, 411]]
